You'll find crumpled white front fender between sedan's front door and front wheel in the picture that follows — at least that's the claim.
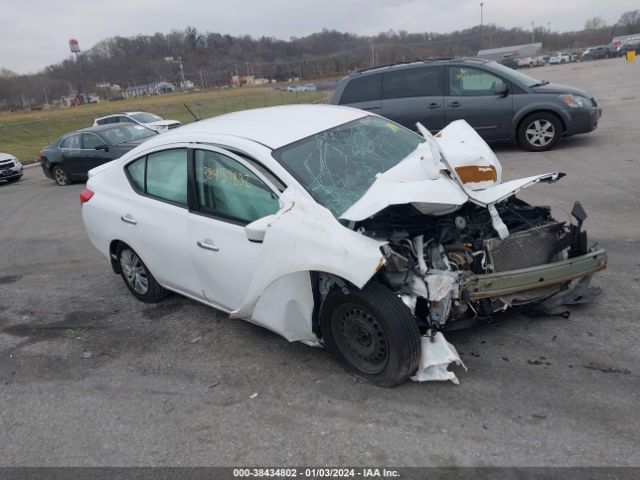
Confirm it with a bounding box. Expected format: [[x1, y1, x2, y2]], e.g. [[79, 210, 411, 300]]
[[231, 187, 385, 322]]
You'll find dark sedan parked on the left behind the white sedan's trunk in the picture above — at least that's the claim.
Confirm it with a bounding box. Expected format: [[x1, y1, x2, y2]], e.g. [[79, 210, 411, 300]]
[[40, 124, 157, 185]]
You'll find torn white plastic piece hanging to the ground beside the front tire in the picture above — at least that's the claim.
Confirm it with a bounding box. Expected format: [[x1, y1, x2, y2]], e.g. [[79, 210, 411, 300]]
[[411, 332, 467, 385]]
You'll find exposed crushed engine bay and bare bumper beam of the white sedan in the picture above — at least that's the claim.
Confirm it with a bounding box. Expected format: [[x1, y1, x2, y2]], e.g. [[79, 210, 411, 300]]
[[357, 196, 607, 333]]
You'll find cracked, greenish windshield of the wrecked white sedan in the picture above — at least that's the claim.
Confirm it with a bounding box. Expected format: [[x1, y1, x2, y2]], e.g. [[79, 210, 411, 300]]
[[274, 117, 424, 217]]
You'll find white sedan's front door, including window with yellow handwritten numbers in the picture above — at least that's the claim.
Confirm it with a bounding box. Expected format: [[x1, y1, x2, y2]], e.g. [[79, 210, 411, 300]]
[[189, 147, 279, 311]]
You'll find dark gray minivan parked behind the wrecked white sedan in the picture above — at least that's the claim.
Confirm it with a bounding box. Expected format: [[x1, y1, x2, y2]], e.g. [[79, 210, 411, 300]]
[[331, 58, 601, 151]]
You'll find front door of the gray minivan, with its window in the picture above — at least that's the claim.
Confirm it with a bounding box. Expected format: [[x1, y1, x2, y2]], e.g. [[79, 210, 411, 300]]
[[444, 65, 513, 140]]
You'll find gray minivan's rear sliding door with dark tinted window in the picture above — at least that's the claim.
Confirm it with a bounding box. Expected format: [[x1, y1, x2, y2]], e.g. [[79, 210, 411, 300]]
[[382, 65, 445, 133]]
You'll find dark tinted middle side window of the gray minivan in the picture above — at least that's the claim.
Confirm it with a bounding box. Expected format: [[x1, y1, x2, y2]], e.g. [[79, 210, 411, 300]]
[[382, 66, 444, 99]]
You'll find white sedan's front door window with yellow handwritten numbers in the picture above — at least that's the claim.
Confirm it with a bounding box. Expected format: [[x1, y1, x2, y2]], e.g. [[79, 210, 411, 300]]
[[195, 150, 280, 223]]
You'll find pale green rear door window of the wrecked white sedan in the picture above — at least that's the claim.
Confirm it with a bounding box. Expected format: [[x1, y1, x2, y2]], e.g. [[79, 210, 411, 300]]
[[147, 149, 187, 205]]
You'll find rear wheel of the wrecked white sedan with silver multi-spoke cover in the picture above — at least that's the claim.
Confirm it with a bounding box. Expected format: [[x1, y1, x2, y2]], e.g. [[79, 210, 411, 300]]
[[116, 243, 169, 303]]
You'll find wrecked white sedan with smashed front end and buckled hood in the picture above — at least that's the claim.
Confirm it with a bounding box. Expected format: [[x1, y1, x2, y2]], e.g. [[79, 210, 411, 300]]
[[81, 105, 607, 387]]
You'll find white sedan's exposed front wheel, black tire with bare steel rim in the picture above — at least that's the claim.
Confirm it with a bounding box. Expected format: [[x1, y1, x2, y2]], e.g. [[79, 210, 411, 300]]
[[320, 281, 420, 387]]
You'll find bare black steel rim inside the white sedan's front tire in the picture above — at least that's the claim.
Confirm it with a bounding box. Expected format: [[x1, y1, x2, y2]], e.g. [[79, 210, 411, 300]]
[[331, 303, 389, 375]]
